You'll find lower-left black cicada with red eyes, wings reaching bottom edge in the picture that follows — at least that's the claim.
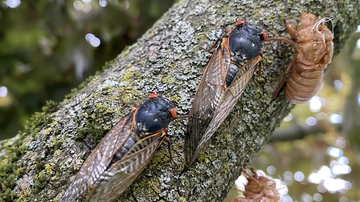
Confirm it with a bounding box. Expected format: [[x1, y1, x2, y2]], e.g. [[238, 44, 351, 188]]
[[60, 94, 176, 202]]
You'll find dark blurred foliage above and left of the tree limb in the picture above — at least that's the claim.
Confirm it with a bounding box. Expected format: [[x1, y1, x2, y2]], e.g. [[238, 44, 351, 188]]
[[0, 0, 174, 140]]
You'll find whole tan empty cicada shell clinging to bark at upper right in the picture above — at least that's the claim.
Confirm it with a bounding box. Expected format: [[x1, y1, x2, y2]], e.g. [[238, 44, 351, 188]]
[[268, 13, 334, 104]]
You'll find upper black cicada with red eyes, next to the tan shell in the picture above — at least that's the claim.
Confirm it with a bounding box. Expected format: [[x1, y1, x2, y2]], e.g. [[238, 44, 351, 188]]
[[185, 20, 266, 165]]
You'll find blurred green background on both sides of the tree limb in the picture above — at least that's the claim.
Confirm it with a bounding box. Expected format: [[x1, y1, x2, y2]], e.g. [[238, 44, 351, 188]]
[[0, 0, 360, 202]]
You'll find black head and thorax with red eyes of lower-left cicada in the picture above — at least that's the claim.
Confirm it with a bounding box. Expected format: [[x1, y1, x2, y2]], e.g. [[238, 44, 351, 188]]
[[135, 93, 176, 136]]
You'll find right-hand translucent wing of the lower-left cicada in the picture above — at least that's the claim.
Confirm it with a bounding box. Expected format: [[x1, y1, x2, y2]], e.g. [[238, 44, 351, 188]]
[[87, 131, 165, 202]]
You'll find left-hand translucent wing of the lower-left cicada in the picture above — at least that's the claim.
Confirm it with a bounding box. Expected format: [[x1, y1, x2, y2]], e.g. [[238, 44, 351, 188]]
[[60, 109, 136, 202]]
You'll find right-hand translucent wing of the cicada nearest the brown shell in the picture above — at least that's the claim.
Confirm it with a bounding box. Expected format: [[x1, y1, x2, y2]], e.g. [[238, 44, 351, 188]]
[[191, 56, 261, 162]]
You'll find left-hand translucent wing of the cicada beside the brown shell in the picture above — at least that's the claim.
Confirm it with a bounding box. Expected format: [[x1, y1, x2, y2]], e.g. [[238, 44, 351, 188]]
[[185, 38, 230, 164]]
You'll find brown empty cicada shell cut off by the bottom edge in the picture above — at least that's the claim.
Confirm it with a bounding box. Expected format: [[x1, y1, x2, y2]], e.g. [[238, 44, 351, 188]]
[[234, 168, 280, 202]]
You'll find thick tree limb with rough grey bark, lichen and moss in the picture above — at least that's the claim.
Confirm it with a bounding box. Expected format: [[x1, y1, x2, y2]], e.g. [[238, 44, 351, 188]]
[[0, 0, 360, 201]]
